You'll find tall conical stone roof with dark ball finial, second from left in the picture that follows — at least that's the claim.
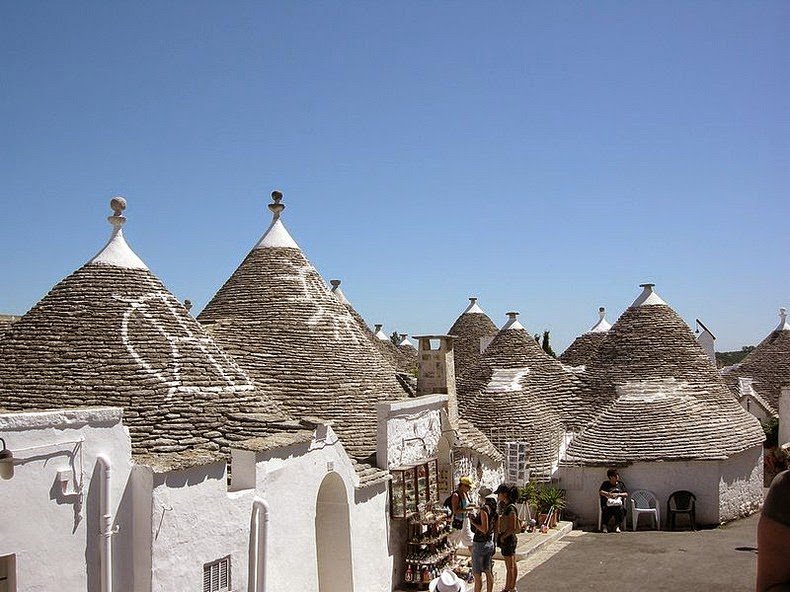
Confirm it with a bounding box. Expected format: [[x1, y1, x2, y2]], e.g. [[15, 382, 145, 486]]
[[198, 192, 405, 458]]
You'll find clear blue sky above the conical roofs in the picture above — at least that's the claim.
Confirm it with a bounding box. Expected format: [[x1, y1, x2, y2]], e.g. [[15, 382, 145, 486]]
[[0, 0, 790, 352]]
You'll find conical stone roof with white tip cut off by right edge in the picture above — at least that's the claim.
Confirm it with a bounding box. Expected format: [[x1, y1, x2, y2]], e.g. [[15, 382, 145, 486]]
[[724, 308, 790, 413]]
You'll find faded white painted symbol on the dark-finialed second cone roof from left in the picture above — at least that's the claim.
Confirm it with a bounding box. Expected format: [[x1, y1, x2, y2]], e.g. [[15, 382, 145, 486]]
[[275, 261, 362, 343]]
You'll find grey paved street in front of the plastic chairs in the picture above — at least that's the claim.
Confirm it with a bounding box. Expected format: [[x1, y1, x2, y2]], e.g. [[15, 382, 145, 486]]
[[516, 515, 758, 592]]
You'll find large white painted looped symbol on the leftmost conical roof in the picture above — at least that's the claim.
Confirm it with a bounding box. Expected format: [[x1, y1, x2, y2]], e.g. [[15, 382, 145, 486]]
[[113, 290, 254, 397]]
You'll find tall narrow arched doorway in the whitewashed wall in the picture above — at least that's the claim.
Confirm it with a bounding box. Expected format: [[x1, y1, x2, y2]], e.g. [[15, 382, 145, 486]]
[[315, 473, 354, 592]]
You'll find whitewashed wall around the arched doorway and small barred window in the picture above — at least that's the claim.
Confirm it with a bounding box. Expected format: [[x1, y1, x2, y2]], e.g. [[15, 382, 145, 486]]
[[143, 428, 392, 592]]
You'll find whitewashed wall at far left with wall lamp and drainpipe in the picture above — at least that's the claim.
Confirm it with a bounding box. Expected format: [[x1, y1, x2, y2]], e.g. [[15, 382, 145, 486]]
[[0, 408, 132, 592]]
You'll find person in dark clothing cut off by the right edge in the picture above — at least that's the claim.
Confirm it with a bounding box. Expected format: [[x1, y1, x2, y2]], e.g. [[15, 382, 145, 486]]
[[757, 471, 790, 592]]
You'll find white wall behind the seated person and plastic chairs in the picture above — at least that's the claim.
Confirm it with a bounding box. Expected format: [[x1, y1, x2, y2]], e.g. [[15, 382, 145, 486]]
[[559, 446, 763, 526]]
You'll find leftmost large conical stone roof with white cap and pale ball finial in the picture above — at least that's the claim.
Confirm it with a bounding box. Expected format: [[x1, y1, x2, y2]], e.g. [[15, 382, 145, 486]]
[[0, 198, 287, 453]]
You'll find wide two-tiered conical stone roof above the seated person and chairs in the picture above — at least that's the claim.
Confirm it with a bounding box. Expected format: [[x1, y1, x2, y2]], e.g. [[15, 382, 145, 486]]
[[566, 284, 764, 464]]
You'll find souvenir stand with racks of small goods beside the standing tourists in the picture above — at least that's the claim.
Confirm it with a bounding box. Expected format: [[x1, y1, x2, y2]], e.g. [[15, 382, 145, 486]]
[[390, 458, 474, 590]]
